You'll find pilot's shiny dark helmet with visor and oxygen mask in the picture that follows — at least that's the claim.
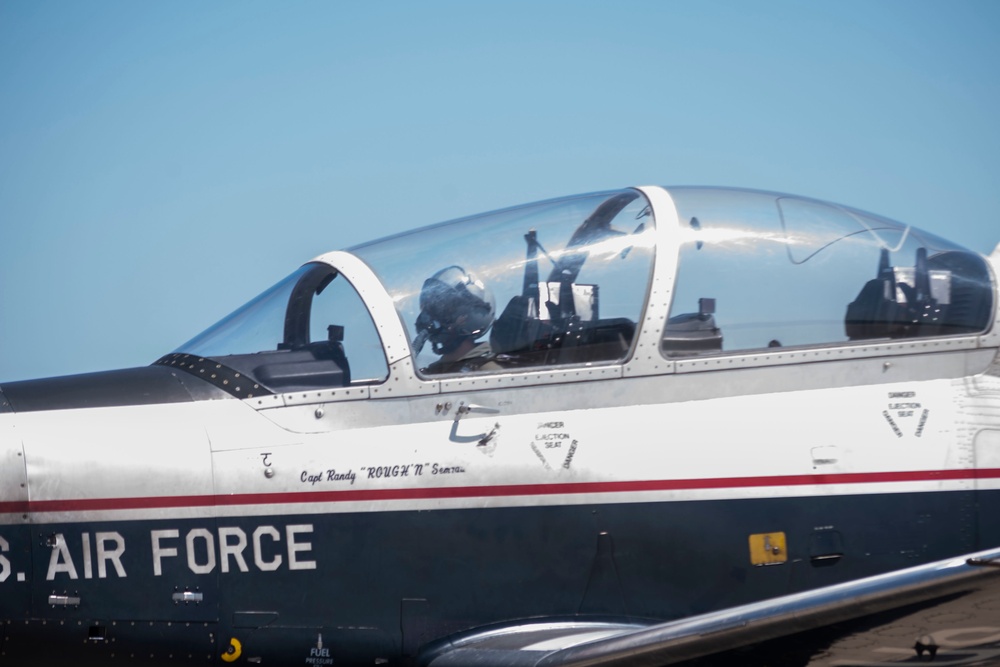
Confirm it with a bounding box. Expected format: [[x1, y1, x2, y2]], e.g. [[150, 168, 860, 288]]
[[415, 266, 496, 354]]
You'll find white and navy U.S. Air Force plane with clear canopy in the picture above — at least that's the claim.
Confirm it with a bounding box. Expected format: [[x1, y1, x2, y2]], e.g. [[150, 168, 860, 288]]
[[0, 187, 1000, 667]]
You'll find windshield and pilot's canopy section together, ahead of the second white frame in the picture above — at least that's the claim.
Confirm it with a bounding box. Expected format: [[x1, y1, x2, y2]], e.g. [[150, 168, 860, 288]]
[[157, 190, 656, 398]]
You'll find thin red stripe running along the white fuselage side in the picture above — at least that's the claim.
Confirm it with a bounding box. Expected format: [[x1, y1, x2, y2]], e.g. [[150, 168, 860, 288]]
[[7, 468, 1000, 514]]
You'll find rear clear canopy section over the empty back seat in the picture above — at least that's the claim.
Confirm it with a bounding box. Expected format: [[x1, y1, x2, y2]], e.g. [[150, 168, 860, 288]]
[[663, 188, 994, 356]]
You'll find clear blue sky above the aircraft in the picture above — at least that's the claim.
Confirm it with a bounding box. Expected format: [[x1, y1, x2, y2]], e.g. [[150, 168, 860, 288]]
[[0, 0, 1000, 381]]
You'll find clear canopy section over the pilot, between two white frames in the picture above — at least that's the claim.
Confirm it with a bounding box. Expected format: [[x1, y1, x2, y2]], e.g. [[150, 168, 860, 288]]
[[353, 190, 656, 376]]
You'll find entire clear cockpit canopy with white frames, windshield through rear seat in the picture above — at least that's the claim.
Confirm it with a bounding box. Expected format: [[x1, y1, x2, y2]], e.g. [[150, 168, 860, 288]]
[[157, 187, 995, 398]]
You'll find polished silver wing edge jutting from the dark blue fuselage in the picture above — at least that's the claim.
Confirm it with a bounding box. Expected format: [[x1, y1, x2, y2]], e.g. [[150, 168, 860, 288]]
[[420, 549, 1000, 667]]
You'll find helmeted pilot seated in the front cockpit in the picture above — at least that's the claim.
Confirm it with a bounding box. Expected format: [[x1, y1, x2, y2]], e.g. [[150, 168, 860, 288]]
[[413, 266, 500, 374]]
